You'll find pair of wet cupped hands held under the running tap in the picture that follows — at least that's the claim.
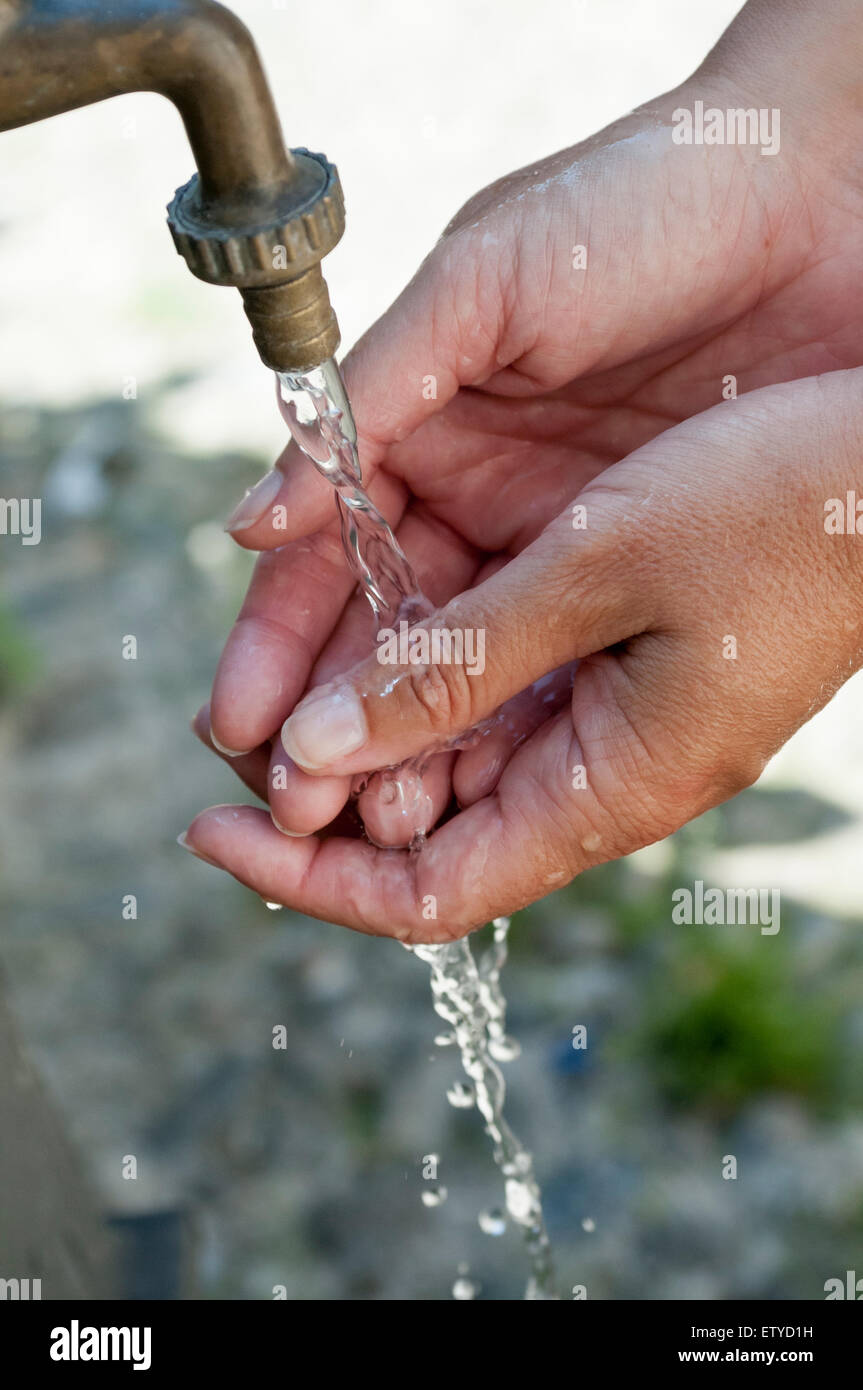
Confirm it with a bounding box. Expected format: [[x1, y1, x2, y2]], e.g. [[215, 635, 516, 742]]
[[185, 0, 863, 941]]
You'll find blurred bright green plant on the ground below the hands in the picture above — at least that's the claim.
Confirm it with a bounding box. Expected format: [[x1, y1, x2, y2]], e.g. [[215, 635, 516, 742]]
[[547, 828, 855, 1116]]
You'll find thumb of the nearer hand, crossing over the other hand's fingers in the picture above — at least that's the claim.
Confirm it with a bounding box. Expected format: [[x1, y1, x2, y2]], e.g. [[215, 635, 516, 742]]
[[282, 505, 650, 774]]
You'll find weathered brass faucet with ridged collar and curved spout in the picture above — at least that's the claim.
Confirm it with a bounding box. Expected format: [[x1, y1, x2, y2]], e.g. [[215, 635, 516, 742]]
[[0, 0, 345, 371]]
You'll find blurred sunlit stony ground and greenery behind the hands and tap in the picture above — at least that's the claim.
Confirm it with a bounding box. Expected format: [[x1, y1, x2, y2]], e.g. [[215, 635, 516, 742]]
[[0, 0, 863, 1300]]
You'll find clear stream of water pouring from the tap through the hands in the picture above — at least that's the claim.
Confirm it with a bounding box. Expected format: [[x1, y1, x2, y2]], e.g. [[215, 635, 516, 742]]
[[277, 359, 557, 1300]]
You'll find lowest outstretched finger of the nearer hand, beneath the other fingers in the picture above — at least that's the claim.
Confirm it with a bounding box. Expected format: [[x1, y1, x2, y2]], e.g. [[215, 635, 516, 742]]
[[185, 710, 611, 942]]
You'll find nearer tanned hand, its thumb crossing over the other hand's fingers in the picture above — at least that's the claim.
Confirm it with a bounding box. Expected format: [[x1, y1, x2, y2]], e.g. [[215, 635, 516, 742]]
[[188, 370, 863, 941]]
